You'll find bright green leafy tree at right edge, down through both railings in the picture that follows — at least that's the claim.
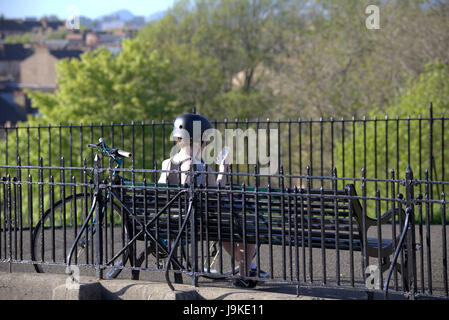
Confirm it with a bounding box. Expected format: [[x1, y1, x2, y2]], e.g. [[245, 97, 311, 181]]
[[335, 61, 449, 220]]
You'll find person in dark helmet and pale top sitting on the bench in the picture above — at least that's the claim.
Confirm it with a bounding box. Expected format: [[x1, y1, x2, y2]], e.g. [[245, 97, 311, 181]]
[[158, 113, 257, 288]]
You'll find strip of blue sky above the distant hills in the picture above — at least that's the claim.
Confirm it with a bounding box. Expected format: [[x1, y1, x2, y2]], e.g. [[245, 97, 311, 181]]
[[0, 0, 175, 19]]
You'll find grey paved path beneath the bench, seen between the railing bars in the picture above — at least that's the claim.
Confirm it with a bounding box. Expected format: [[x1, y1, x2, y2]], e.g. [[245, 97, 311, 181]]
[[0, 225, 449, 299]]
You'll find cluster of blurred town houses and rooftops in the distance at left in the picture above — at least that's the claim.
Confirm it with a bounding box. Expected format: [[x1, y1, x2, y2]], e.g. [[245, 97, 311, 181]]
[[0, 17, 145, 127]]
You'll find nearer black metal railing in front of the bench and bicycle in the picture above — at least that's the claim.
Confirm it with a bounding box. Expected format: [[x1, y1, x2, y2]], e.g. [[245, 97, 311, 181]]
[[0, 160, 449, 298]]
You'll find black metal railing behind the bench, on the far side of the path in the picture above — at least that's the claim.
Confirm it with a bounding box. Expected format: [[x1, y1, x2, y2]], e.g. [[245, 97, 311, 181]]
[[0, 106, 448, 193]]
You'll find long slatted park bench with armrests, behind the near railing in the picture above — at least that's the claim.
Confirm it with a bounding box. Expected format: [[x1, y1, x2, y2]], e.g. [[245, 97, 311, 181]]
[[113, 183, 407, 289]]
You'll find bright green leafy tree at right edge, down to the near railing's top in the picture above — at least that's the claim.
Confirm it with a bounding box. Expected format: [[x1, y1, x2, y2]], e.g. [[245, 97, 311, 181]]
[[336, 61, 449, 177]]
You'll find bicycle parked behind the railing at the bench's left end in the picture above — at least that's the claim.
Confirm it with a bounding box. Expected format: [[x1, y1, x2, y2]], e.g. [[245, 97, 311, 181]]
[[31, 138, 172, 279]]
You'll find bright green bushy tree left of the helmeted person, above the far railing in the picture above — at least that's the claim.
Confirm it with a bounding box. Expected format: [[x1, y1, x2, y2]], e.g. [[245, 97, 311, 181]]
[[28, 40, 178, 124]]
